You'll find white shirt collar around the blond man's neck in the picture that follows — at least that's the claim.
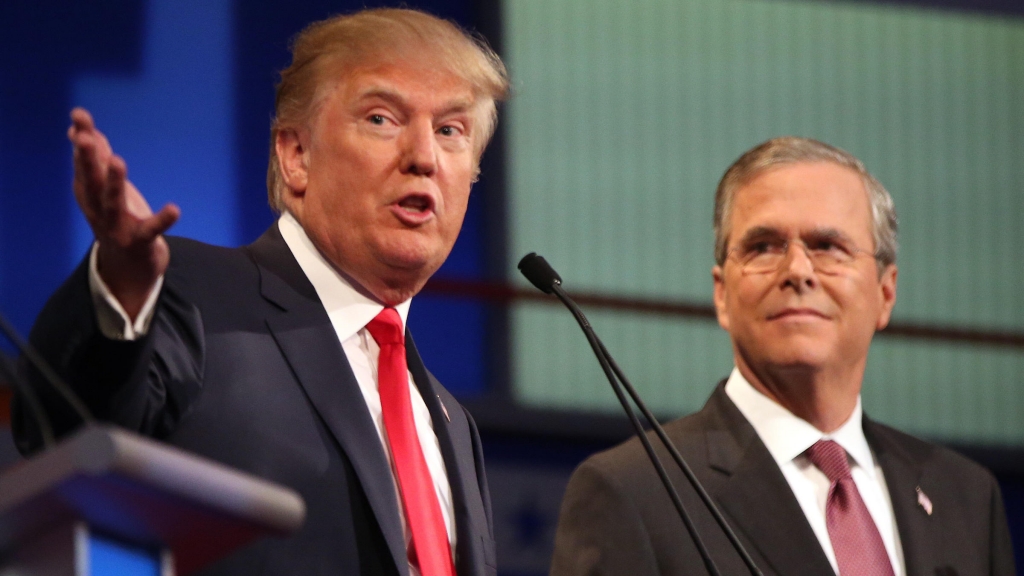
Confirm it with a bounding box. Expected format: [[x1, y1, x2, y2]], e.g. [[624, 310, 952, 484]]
[[278, 212, 412, 341]]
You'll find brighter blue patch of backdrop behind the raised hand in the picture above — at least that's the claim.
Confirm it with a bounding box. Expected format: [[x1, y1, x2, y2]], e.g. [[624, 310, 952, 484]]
[[68, 0, 239, 259]]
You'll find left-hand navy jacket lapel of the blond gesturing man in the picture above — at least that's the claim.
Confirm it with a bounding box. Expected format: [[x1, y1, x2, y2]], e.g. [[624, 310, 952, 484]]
[[250, 225, 408, 574]]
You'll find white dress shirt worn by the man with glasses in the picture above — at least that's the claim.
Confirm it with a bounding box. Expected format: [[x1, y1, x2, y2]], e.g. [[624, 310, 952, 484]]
[[725, 368, 906, 576]]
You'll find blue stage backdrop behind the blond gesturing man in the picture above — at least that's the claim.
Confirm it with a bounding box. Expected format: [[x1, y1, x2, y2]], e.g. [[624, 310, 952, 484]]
[[0, 0, 486, 397]]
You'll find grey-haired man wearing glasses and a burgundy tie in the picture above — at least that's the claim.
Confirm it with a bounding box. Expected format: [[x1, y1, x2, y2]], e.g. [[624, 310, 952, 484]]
[[552, 137, 1014, 576]]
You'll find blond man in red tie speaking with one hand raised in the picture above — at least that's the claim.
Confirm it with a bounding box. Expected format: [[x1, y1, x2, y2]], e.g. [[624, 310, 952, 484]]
[[14, 9, 508, 576]]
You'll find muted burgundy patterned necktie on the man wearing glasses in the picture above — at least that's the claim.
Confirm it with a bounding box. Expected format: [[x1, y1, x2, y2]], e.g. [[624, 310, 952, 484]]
[[807, 440, 893, 576]]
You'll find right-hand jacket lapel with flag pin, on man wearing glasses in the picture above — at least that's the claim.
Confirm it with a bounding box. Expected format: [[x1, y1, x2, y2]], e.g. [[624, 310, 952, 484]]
[[864, 417, 942, 576]]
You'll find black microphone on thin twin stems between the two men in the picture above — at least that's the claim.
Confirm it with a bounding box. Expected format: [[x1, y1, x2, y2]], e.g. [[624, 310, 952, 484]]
[[518, 252, 762, 576]]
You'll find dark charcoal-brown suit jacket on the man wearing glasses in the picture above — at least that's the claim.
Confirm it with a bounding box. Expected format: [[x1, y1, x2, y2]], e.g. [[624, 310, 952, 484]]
[[551, 382, 1014, 576]]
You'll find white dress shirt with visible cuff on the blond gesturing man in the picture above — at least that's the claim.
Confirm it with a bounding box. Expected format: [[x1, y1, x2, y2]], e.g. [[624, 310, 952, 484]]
[[89, 212, 456, 576]]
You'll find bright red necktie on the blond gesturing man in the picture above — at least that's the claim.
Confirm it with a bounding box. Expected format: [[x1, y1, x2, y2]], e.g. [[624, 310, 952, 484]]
[[367, 307, 455, 576]]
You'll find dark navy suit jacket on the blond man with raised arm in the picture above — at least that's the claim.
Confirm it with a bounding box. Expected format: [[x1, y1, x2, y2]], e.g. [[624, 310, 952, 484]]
[[13, 225, 496, 576]]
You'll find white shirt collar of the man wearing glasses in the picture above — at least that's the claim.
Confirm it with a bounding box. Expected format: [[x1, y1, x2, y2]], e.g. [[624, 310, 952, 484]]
[[725, 368, 876, 478]]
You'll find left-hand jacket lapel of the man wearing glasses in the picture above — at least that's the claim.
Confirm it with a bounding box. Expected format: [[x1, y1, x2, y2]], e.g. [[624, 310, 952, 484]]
[[705, 385, 833, 576]]
